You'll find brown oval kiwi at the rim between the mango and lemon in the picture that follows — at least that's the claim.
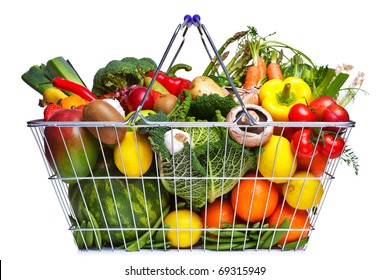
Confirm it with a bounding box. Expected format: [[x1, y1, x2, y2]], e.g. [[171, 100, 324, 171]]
[[82, 100, 127, 144]]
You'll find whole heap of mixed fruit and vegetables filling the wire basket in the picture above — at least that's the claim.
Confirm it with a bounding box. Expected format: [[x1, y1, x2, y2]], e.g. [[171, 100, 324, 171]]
[[22, 27, 364, 251]]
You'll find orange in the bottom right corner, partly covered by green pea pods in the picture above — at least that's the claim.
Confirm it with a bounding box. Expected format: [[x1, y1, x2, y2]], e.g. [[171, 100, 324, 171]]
[[266, 199, 310, 245]]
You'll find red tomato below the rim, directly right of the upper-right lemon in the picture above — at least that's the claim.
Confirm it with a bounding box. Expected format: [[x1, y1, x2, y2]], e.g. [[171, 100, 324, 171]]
[[291, 128, 317, 158]]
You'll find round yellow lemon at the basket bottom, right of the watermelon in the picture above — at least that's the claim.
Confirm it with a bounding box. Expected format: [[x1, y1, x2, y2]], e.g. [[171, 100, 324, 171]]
[[164, 209, 203, 248]]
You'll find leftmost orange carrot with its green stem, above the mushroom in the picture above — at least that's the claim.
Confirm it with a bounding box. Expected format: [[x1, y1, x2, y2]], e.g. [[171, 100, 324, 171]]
[[244, 39, 267, 89]]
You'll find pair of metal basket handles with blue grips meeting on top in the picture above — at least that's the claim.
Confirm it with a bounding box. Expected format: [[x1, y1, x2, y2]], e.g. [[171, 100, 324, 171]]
[[128, 14, 256, 125]]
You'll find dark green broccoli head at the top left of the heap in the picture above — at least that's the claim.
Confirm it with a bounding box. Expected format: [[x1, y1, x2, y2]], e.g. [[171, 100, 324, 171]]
[[92, 57, 157, 97]]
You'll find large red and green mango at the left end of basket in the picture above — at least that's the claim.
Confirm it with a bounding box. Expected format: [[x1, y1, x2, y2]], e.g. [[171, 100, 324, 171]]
[[44, 108, 100, 183]]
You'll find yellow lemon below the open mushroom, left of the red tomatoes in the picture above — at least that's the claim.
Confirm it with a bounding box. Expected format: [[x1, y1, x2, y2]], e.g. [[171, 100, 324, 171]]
[[258, 135, 297, 183]]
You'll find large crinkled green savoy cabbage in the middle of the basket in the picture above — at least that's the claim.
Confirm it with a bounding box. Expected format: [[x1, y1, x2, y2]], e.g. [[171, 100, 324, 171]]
[[141, 92, 257, 208]]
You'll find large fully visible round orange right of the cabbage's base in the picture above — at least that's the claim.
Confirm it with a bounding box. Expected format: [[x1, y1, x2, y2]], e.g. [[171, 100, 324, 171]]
[[231, 172, 279, 222]]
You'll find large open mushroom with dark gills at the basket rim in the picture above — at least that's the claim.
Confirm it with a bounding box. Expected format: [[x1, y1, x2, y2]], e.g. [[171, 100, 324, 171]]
[[226, 104, 274, 148]]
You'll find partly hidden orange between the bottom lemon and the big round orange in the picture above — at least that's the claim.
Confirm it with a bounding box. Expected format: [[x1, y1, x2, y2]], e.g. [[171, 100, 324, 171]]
[[200, 197, 234, 228]]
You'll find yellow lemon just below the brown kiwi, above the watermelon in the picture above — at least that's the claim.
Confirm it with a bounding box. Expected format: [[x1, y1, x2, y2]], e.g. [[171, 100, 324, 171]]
[[114, 131, 153, 177]]
